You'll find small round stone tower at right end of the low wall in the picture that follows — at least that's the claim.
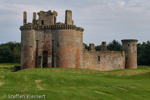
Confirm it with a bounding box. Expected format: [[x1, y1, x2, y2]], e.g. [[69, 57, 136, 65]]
[[121, 39, 138, 69]]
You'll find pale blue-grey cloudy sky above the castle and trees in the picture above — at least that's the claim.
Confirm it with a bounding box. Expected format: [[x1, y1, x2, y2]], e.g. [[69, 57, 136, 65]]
[[0, 0, 150, 45]]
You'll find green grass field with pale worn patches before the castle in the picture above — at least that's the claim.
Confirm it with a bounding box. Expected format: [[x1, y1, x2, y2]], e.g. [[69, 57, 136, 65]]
[[0, 64, 150, 100]]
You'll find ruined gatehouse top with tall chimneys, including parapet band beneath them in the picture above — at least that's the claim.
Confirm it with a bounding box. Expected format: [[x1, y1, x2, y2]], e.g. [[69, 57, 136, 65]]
[[20, 10, 84, 31]]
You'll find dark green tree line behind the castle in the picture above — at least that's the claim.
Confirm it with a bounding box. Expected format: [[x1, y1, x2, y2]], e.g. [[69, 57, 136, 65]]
[[0, 40, 150, 65]]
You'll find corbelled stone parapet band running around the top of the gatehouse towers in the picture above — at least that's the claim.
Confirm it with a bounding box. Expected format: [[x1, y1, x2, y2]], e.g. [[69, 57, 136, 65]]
[[20, 24, 84, 31]]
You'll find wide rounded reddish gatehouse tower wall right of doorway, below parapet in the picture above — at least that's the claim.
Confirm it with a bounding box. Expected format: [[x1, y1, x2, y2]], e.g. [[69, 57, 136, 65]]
[[52, 29, 83, 68]]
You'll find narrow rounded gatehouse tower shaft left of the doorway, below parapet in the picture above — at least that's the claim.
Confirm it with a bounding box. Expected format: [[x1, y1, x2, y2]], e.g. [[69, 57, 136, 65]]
[[21, 30, 36, 69]]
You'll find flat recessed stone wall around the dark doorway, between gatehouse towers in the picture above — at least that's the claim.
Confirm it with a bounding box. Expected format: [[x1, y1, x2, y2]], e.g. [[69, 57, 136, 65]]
[[36, 30, 52, 67]]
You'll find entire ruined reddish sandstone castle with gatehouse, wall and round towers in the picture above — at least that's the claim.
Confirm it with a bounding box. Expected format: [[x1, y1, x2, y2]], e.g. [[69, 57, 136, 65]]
[[20, 10, 137, 71]]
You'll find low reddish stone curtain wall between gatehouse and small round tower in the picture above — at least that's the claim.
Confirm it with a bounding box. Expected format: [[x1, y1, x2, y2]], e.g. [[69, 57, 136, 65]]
[[83, 50, 125, 71]]
